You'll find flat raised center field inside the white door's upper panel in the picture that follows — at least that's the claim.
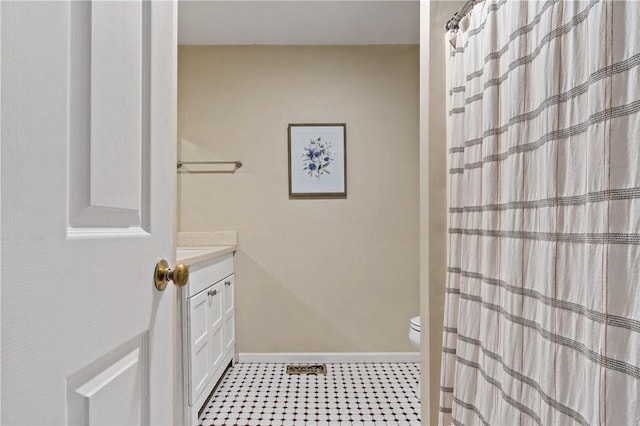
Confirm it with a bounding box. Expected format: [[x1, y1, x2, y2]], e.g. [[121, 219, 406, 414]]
[[87, 2, 145, 211]]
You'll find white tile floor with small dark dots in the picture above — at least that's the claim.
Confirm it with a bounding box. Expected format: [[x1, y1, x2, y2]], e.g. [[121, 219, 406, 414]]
[[200, 363, 420, 426]]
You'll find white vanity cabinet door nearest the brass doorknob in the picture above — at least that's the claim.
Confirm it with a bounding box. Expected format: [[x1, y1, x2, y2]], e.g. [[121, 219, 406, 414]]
[[187, 290, 213, 404]]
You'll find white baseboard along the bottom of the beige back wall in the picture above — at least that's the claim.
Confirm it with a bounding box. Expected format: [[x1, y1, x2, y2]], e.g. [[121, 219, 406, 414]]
[[238, 352, 420, 364]]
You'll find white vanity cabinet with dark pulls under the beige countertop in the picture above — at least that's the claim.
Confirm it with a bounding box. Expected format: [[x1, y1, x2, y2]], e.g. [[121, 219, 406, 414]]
[[179, 253, 235, 425]]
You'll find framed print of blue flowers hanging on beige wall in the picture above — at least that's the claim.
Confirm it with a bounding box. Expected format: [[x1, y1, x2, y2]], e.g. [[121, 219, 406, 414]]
[[288, 123, 347, 198]]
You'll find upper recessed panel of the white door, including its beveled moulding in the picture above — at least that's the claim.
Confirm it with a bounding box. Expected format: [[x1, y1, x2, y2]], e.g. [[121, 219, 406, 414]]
[[69, 1, 151, 236]]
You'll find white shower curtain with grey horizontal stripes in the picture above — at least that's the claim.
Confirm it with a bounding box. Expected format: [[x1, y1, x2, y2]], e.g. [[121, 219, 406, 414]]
[[440, 0, 640, 425]]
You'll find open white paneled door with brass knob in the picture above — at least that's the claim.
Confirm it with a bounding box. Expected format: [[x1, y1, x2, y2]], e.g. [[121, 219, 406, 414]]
[[0, 1, 176, 425]]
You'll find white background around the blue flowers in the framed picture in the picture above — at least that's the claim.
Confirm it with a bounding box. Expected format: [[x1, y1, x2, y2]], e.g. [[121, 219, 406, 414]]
[[289, 126, 345, 194]]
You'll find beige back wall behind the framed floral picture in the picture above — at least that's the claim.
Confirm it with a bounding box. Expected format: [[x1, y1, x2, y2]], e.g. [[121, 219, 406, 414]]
[[178, 46, 420, 352]]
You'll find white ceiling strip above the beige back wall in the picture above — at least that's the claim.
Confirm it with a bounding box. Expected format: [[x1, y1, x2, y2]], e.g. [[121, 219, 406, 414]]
[[178, 0, 420, 44]]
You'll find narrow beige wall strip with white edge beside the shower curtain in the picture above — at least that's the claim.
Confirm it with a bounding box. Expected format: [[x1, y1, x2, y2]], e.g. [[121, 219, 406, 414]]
[[420, 0, 464, 424]]
